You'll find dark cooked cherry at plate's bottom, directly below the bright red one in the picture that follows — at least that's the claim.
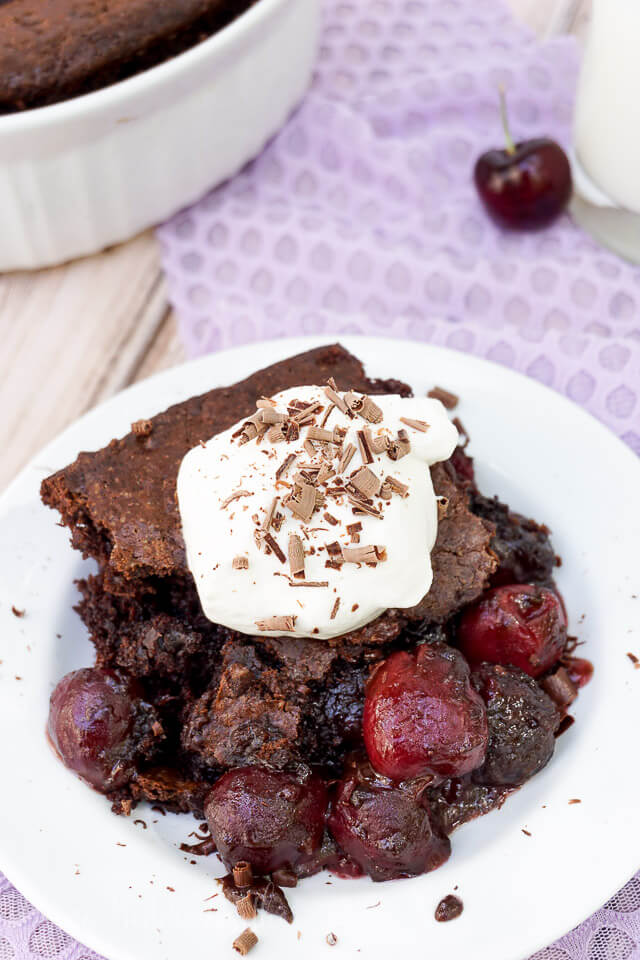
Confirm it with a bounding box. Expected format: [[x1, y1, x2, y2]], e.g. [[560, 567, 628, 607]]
[[329, 759, 451, 880]]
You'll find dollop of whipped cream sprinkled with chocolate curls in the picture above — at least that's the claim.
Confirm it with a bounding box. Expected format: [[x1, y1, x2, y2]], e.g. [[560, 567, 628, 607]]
[[178, 385, 458, 638]]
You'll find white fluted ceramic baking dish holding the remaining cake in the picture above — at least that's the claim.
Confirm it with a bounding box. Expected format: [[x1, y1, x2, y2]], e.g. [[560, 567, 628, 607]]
[[0, 0, 321, 271]]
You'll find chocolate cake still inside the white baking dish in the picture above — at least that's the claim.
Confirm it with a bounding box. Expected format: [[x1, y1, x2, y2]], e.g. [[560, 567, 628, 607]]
[[0, 0, 256, 113]]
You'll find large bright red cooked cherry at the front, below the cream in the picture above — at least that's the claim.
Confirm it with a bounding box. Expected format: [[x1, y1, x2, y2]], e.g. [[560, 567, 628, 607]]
[[364, 643, 487, 780]]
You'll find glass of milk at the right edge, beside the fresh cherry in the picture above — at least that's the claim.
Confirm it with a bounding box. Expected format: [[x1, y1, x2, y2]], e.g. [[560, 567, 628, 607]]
[[572, 0, 640, 263]]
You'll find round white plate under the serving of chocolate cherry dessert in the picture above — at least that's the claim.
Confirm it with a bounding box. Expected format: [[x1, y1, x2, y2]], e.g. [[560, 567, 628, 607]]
[[0, 337, 640, 960]]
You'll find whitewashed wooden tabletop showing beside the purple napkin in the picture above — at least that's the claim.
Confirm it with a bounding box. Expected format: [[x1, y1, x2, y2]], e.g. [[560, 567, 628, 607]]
[[0, 0, 590, 492]]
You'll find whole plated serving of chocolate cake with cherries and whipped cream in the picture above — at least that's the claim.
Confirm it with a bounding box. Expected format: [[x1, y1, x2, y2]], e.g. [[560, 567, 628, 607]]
[[42, 345, 589, 920]]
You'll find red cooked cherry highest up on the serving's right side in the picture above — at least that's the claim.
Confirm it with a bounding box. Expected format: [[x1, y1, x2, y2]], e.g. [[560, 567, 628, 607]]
[[458, 584, 567, 677]]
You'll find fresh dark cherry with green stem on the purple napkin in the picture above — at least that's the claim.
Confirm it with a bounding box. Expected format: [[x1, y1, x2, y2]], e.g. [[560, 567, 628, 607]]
[[474, 92, 572, 230]]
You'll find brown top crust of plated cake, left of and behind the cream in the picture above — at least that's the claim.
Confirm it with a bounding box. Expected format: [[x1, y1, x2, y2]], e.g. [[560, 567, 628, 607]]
[[41, 344, 411, 581]]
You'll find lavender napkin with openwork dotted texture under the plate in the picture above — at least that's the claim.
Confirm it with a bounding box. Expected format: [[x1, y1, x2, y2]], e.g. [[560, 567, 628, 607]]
[[0, 0, 640, 960]]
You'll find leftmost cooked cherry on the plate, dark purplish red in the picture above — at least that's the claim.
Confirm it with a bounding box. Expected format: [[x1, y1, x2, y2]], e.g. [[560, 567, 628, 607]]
[[49, 667, 154, 793]]
